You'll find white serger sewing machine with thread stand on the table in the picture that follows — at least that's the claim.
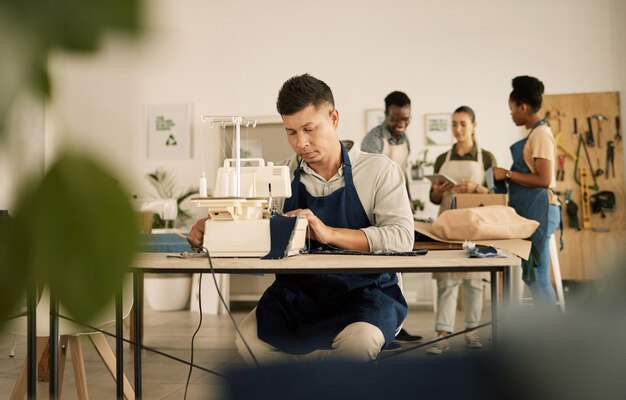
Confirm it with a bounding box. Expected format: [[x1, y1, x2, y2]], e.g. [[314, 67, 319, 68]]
[[191, 117, 308, 257]]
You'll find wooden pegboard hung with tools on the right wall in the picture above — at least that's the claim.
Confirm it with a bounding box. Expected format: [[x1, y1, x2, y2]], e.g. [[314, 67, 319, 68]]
[[542, 92, 626, 280]]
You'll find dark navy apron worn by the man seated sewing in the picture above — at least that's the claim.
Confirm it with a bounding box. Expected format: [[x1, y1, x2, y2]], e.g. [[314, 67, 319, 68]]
[[256, 145, 407, 354]]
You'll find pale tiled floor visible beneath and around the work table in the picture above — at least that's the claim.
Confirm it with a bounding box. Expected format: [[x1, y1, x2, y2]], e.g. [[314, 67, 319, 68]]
[[0, 304, 490, 400]]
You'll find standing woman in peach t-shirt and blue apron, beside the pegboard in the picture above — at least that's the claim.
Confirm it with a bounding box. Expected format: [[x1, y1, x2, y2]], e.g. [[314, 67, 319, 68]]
[[494, 76, 561, 305]]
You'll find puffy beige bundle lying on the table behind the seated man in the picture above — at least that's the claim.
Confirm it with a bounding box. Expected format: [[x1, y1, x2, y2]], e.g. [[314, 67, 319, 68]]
[[432, 206, 539, 240]]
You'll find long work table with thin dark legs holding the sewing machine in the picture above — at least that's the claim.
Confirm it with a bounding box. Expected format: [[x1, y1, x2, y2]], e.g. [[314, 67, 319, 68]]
[[117, 250, 521, 399]]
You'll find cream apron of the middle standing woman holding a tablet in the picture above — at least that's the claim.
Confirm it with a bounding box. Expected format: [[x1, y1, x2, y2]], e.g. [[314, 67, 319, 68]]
[[433, 145, 487, 279]]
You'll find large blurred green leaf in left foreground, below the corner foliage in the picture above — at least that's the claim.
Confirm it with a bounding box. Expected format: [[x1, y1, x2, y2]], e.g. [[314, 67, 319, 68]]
[[16, 153, 137, 321]]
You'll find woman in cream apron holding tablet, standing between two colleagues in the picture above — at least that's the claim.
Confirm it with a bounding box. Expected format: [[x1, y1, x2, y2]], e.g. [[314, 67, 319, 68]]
[[427, 106, 496, 354]]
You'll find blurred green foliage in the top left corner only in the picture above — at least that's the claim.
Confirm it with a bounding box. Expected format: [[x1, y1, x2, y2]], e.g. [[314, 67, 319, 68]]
[[0, 0, 141, 136]]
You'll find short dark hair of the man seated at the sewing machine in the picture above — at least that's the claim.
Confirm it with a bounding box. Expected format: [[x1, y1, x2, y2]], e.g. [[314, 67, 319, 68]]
[[276, 74, 335, 115]]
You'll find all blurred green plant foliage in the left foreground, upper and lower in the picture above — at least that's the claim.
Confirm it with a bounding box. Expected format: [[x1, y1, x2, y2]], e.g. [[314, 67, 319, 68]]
[[0, 0, 141, 324]]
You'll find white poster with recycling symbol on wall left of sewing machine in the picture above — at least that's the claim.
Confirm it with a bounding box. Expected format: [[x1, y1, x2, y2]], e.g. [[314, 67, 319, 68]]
[[146, 103, 191, 160]]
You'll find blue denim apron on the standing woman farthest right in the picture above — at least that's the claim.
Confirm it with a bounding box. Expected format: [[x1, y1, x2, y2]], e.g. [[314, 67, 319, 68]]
[[509, 119, 549, 283]]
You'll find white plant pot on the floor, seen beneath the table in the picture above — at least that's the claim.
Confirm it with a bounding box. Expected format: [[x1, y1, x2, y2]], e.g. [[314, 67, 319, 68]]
[[144, 274, 191, 311]]
